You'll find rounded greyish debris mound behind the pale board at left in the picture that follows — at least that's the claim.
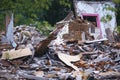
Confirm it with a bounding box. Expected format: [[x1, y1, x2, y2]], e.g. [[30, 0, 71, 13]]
[[14, 25, 45, 49]]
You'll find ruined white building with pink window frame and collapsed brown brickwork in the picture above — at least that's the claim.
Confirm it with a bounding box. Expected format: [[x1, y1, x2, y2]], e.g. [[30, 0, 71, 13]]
[[51, 0, 116, 42]]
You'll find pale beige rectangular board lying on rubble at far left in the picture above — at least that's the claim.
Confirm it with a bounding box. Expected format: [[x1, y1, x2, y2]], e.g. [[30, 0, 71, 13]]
[[1, 48, 32, 60]]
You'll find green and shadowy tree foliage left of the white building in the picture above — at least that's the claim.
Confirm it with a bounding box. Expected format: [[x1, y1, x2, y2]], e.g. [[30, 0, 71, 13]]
[[0, 0, 70, 35]]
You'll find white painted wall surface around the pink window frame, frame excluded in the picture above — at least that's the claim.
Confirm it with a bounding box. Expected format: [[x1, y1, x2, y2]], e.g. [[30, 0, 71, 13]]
[[76, 1, 116, 38]]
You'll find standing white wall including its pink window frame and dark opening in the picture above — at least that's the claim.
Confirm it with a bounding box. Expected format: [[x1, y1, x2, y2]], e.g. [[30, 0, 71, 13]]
[[75, 0, 116, 38]]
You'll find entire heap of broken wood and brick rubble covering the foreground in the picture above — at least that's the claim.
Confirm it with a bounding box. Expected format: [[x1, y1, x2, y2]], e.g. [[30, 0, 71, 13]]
[[0, 19, 120, 80]]
